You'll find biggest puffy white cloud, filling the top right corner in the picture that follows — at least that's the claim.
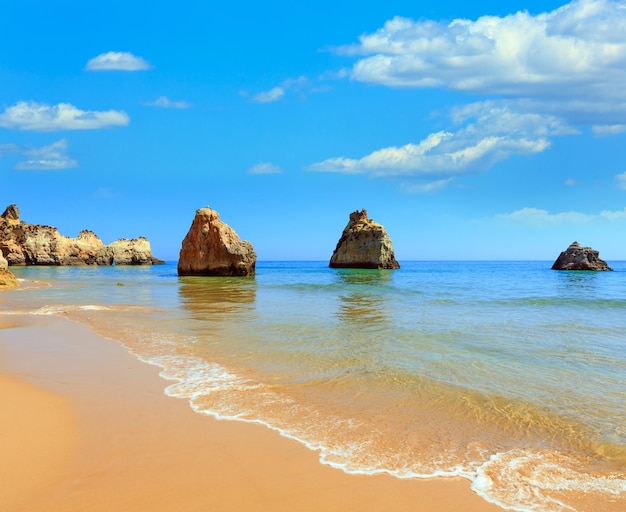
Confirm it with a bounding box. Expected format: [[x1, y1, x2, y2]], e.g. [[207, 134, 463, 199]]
[[339, 0, 626, 127]]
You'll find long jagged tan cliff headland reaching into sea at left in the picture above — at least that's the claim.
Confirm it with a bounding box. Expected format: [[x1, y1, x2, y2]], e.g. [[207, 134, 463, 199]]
[[0, 205, 162, 265]]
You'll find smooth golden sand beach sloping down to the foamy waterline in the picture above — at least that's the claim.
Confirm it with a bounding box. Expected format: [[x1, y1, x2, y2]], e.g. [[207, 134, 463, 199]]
[[0, 315, 501, 512]]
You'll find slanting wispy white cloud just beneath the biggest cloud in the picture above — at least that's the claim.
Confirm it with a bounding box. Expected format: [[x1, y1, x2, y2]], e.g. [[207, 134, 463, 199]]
[[308, 102, 560, 180]]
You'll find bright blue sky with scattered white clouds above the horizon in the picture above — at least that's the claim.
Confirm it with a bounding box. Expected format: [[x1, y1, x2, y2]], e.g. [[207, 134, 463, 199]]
[[0, 0, 626, 263]]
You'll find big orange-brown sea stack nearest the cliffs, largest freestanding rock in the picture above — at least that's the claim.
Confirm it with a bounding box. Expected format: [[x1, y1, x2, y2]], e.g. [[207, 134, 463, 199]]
[[178, 208, 256, 276]]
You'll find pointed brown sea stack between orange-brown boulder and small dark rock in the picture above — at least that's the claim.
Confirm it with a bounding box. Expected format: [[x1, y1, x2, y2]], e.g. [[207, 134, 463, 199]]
[[329, 209, 400, 269]]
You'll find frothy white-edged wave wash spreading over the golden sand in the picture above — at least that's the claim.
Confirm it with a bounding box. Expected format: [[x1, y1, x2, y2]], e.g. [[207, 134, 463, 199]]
[[122, 342, 626, 512]]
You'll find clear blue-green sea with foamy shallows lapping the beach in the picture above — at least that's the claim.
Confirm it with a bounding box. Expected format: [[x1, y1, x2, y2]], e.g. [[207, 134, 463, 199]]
[[0, 261, 626, 512]]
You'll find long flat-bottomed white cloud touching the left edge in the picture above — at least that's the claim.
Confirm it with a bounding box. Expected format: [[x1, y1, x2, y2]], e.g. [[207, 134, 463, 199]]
[[0, 101, 129, 132]]
